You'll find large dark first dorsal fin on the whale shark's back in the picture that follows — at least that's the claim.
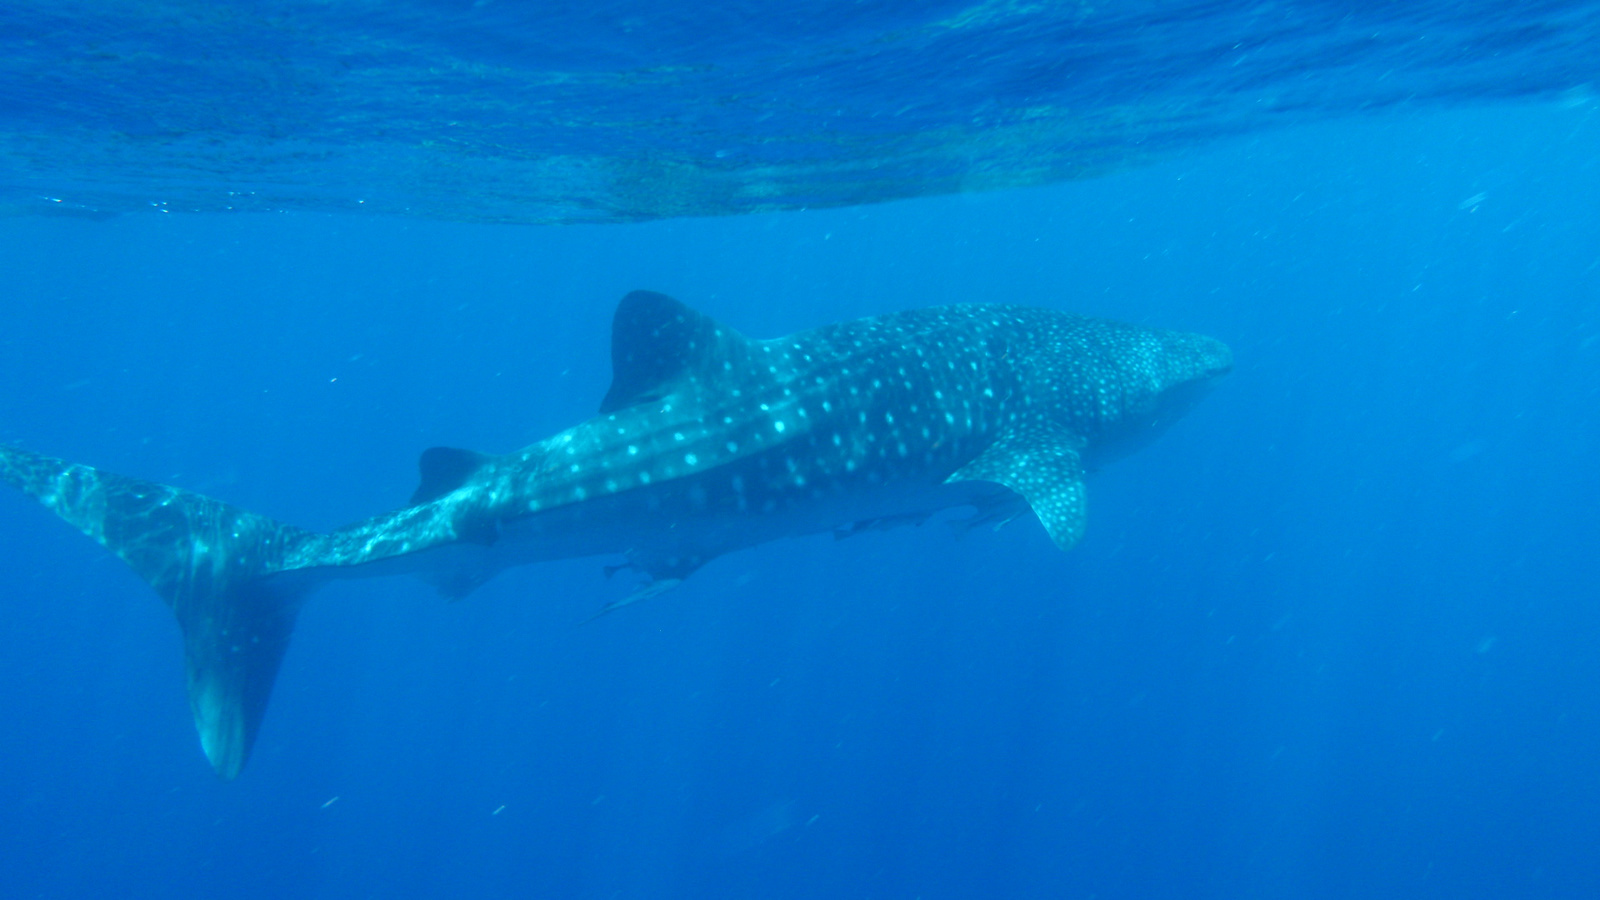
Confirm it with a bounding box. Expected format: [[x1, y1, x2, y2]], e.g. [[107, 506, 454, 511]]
[[600, 290, 750, 413]]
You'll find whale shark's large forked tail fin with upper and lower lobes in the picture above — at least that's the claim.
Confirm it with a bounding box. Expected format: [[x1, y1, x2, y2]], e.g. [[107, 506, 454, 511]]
[[0, 447, 320, 778]]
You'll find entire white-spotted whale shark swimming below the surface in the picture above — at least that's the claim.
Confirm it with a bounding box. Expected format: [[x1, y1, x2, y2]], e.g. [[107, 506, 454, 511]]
[[0, 291, 1232, 778]]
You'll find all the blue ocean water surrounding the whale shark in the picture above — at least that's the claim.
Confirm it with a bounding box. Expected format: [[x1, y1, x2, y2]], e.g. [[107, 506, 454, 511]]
[[0, 3, 1600, 898]]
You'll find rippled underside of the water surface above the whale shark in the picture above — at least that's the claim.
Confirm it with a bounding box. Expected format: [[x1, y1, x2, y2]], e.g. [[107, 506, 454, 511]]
[[9, 0, 1600, 223]]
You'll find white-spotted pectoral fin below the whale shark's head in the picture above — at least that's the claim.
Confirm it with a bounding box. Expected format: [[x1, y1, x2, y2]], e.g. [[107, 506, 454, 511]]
[[947, 429, 1088, 549]]
